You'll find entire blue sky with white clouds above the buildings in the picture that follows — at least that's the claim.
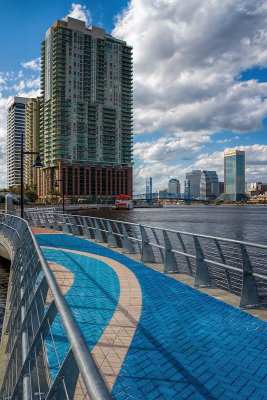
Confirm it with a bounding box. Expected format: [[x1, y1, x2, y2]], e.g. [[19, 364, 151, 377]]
[[0, 0, 267, 193]]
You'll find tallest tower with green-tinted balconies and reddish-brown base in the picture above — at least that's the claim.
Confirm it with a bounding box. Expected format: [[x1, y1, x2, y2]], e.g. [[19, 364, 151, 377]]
[[38, 17, 132, 199]]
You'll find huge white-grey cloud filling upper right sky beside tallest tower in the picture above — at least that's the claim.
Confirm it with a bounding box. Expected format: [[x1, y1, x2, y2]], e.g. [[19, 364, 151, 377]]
[[113, 0, 267, 134]]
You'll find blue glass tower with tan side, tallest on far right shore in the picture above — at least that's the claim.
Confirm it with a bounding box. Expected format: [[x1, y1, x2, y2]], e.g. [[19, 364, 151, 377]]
[[224, 150, 246, 201]]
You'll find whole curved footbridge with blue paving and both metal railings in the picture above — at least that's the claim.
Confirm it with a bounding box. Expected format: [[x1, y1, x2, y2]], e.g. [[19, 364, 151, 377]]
[[0, 211, 267, 400]]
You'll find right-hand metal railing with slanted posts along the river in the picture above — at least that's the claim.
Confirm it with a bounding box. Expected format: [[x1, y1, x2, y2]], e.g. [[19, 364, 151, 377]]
[[26, 209, 267, 308]]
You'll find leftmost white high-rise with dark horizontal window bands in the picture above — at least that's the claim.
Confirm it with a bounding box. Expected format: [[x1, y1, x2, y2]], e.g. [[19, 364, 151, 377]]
[[7, 97, 29, 187]]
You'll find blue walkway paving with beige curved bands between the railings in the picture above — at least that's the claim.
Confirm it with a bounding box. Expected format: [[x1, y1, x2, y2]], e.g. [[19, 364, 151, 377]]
[[34, 228, 267, 400]]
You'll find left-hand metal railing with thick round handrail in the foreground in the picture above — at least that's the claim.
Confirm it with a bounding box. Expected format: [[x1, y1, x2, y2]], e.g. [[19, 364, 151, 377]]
[[0, 214, 111, 400]]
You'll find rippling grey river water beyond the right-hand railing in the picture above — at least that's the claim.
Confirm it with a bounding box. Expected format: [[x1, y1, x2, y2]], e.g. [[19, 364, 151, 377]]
[[75, 205, 267, 245]]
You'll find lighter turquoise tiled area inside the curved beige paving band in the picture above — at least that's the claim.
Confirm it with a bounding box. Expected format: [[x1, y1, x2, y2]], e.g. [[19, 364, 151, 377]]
[[40, 245, 120, 379]]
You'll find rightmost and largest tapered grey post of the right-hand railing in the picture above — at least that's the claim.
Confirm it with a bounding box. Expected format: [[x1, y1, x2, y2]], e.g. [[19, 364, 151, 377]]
[[239, 244, 261, 308]]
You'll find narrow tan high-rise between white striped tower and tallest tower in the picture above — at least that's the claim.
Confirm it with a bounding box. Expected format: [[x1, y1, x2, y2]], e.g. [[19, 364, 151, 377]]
[[24, 97, 40, 188]]
